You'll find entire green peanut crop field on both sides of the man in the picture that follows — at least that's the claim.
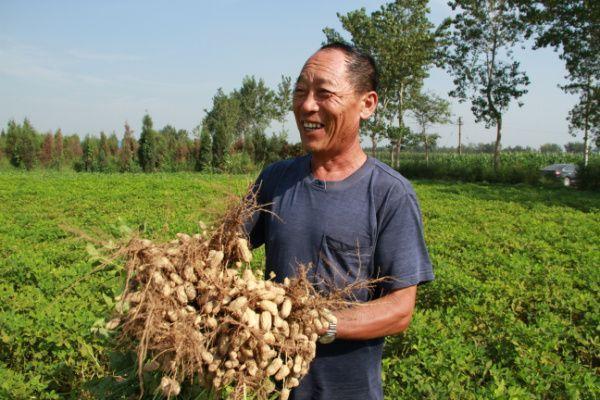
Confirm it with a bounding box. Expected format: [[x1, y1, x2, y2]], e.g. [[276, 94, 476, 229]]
[[0, 172, 600, 399]]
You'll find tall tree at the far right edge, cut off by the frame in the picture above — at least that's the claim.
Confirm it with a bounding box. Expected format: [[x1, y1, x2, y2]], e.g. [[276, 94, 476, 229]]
[[512, 0, 600, 165]]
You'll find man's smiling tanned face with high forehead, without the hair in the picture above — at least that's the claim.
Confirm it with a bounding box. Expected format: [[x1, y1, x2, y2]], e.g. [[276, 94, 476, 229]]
[[293, 49, 372, 155]]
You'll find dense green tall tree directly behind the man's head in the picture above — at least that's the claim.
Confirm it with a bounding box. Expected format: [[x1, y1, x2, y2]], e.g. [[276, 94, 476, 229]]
[[323, 0, 436, 166]]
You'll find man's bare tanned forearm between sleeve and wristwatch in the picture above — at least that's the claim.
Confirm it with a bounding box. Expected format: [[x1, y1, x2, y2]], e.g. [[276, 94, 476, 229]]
[[318, 285, 417, 340]]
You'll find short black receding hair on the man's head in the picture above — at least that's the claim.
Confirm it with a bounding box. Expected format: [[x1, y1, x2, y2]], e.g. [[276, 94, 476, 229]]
[[319, 42, 379, 93]]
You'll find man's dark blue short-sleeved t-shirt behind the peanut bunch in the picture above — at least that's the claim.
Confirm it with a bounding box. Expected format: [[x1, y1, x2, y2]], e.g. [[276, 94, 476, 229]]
[[247, 155, 433, 400]]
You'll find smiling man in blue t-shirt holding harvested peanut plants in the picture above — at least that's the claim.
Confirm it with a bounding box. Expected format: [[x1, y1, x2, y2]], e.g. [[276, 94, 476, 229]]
[[248, 44, 433, 400]]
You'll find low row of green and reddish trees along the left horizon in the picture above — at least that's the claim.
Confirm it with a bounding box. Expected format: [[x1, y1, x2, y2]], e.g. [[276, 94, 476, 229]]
[[0, 115, 302, 172]]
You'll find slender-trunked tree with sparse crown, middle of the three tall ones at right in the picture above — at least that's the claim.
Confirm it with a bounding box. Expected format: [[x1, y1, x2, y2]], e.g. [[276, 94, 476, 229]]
[[444, 0, 529, 169]]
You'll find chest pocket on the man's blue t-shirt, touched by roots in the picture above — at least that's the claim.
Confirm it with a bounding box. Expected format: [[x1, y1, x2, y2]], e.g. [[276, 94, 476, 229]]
[[315, 234, 373, 301]]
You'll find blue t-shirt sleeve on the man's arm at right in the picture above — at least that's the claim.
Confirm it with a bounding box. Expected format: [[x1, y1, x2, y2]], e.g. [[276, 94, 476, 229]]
[[374, 190, 434, 295]]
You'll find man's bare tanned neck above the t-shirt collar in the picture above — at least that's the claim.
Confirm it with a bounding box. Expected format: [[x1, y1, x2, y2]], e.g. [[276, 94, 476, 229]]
[[311, 142, 367, 181]]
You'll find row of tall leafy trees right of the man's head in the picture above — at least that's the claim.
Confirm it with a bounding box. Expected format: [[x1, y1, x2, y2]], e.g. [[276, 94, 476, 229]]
[[323, 0, 600, 168]]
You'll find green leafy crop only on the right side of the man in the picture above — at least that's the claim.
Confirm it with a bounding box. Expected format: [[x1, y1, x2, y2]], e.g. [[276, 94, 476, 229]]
[[384, 184, 600, 399]]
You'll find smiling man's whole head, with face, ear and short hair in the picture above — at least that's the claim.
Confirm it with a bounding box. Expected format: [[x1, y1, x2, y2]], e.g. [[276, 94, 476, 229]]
[[293, 43, 378, 155]]
